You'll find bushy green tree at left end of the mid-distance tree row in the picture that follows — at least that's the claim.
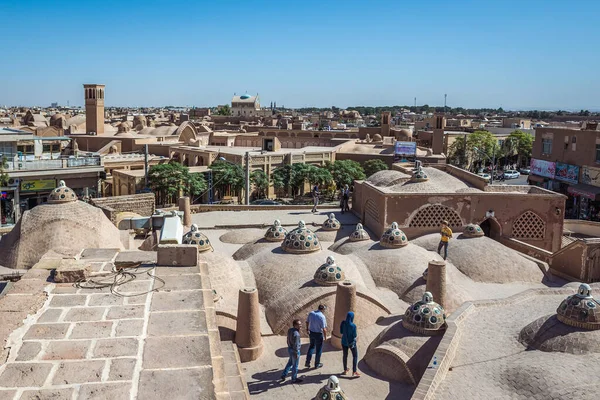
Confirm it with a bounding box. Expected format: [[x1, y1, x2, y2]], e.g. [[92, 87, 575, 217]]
[[148, 161, 206, 204]]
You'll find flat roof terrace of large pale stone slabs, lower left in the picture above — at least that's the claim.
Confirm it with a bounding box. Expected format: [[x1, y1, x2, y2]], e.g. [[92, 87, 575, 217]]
[[0, 250, 246, 400]]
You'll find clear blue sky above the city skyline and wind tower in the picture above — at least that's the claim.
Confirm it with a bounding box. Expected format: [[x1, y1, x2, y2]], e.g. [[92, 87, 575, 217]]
[[0, 0, 600, 110]]
